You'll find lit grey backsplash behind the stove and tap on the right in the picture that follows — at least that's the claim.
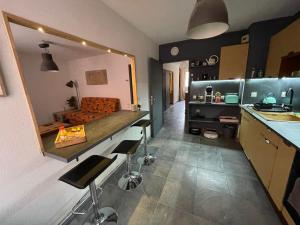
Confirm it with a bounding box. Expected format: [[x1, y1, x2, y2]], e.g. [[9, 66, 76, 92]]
[[243, 78, 300, 111]]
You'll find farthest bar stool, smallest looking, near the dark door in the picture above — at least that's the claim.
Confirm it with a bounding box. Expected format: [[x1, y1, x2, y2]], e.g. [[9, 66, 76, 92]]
[[132, 120, 156, 166]]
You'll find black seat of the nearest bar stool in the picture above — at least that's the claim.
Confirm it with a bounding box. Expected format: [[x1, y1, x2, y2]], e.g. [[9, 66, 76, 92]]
[[59, 155, 118, 189]]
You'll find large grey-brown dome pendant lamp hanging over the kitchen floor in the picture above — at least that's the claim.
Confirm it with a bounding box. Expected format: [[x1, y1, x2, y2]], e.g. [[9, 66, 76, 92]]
[[187, 0, 229, 39]]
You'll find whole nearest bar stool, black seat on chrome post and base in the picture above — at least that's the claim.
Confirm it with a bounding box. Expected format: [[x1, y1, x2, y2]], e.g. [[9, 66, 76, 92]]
[[59, 155, 118, 225]]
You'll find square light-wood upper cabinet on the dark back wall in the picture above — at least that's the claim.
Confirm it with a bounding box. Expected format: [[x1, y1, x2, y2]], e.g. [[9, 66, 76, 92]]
[[219, 44, 249, 80]]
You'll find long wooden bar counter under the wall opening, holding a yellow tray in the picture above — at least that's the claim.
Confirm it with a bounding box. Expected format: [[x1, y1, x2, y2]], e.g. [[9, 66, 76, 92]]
[[42, 110, 148, 162]]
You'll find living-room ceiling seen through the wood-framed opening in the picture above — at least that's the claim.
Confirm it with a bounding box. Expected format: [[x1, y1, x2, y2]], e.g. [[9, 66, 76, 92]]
[[10, 23, 106, 60]]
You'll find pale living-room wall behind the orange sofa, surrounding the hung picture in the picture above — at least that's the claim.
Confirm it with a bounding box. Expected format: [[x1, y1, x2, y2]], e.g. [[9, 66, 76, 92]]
[[67, 54, 131, 110]]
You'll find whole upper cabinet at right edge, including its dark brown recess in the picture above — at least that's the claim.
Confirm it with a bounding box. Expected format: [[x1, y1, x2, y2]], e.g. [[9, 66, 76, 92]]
[[266, 19, 300, 77]]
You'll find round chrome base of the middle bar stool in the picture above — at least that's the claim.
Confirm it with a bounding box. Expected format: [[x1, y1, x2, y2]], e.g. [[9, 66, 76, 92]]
[[118, 171, 143, 191]]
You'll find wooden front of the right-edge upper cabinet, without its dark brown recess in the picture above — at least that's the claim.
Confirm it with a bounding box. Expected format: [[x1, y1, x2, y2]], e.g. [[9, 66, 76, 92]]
[[266, 19, 300, 77]]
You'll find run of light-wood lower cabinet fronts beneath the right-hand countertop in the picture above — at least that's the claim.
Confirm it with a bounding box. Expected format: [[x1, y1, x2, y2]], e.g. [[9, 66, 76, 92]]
[[240, 110, 296, 214]]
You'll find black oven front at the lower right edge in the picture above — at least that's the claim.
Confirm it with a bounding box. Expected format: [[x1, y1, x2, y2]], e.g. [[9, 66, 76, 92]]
[[283, 151, 300, 225]]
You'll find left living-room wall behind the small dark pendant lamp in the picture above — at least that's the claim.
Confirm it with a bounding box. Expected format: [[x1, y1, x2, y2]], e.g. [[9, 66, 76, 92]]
[[19, 52, 75, 124]]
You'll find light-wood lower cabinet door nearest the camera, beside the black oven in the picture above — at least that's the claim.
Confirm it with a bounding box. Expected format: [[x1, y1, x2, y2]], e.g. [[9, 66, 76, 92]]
[[269, 141, 296, 210]]
